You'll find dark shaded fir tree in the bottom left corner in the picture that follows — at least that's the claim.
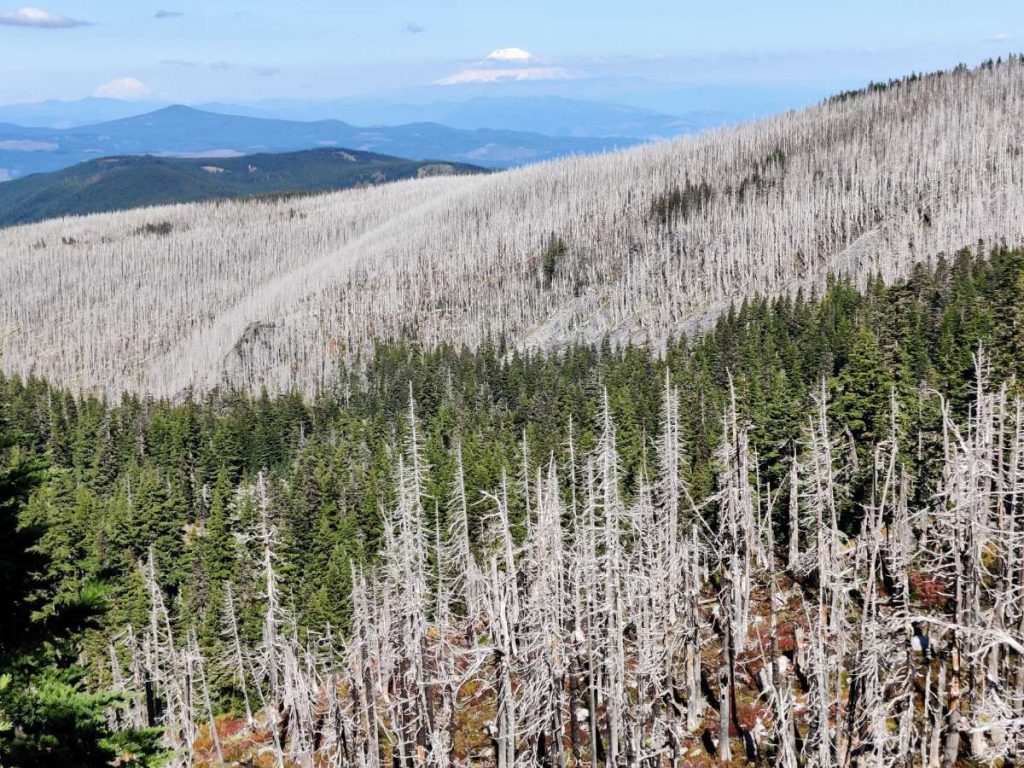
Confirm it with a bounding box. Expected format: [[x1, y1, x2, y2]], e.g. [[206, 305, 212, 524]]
[[0, 370, 162, 768]]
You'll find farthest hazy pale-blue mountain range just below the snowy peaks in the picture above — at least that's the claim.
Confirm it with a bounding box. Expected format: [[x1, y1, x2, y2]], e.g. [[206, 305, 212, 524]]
[[0, 77, 831, 133]]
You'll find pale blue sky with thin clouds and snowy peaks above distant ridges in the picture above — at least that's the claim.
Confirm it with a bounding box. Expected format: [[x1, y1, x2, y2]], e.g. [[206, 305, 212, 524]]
[[0, 0, 1024, 103]]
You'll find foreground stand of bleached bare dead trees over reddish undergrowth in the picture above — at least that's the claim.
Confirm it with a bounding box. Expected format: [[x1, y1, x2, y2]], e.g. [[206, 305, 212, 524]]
[[99, 353, 1024, 768]]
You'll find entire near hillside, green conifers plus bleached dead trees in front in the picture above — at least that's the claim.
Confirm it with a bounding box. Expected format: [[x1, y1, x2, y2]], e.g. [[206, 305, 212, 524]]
[[6, 249, 1024, 768]]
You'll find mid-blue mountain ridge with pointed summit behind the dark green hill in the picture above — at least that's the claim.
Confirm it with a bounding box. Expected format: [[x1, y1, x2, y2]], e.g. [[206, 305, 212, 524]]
[[0, 106, 644, 180]]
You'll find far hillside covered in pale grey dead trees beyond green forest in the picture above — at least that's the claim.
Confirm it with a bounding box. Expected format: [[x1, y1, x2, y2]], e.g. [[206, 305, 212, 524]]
[[0, 59, 1024, 394]]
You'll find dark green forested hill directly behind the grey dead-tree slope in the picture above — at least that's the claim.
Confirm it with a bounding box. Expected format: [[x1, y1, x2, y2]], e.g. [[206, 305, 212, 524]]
[[0, 148, 484, 226]]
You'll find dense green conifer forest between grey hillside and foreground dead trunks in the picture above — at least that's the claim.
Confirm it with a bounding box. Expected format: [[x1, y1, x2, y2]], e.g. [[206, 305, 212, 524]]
[[0, 250, 1024, 766]]
